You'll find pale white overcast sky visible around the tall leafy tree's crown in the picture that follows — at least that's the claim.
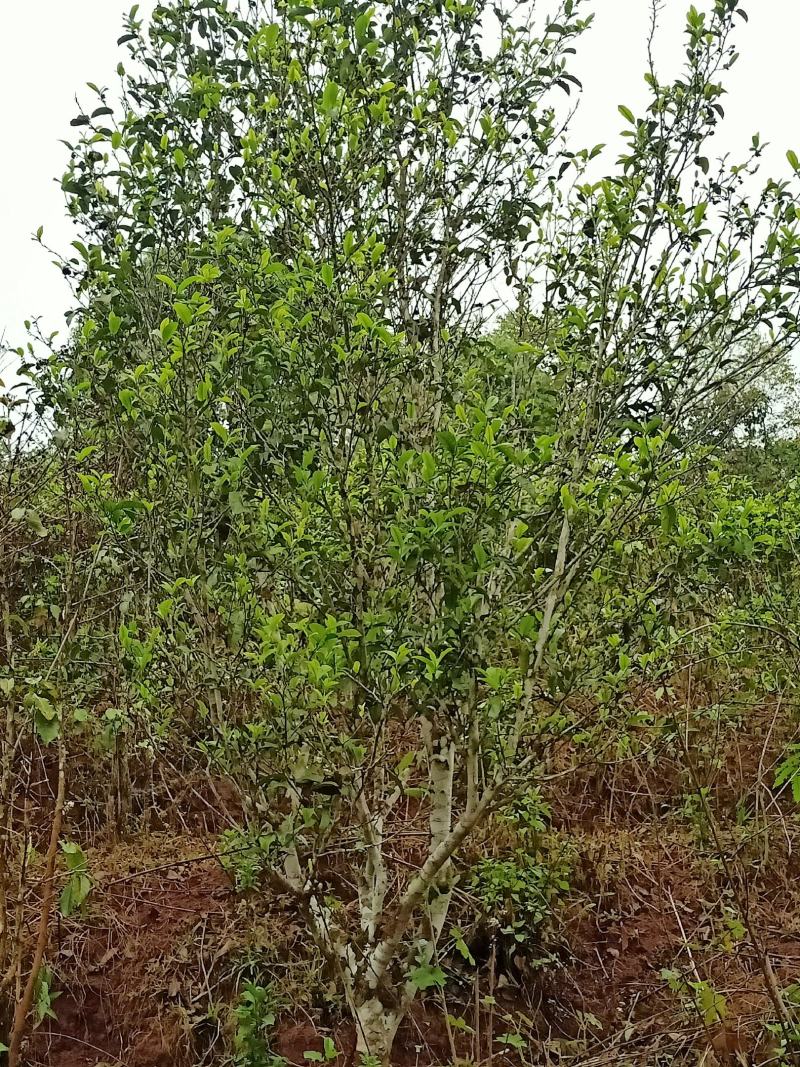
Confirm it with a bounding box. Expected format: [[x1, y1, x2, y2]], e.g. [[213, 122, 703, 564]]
[[0, 0, 800, 356]]
